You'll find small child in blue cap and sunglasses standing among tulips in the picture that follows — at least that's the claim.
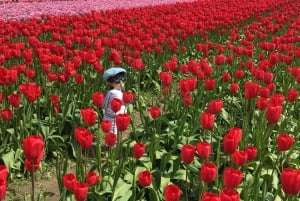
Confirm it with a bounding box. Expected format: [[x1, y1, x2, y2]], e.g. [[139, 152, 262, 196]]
[[103, 67, 132, 134]]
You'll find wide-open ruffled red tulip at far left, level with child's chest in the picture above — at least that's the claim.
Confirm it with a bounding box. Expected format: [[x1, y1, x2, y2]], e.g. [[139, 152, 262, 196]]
[[19, 82, 42, 102]]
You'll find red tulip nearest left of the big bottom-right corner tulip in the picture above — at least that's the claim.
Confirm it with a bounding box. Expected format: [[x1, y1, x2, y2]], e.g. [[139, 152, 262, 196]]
[[223, 167, 243, 188]]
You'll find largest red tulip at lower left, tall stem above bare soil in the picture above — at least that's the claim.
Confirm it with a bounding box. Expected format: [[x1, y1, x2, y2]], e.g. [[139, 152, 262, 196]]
[[22, 135, 45, 163]]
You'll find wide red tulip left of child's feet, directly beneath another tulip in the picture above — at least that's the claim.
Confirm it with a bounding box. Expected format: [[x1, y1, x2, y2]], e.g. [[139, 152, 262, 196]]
[[74, 127, 93, 149]]
